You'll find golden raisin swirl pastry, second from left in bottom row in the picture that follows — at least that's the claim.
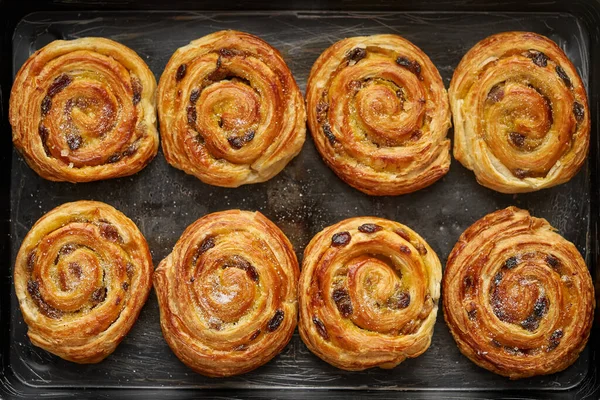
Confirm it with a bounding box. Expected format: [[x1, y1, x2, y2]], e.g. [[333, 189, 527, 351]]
[[154, 210, 299, 377]]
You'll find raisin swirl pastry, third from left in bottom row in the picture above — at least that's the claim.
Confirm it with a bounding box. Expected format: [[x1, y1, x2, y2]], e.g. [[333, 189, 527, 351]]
[[298, 217, 442, 371]]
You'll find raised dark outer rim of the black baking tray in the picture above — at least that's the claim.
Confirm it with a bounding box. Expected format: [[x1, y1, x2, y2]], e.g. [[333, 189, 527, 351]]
[[0, 0, 600, 398]]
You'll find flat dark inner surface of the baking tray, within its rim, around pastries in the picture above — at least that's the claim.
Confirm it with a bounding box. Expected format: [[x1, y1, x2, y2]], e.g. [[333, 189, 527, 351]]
[[9, 12, 593, 391]]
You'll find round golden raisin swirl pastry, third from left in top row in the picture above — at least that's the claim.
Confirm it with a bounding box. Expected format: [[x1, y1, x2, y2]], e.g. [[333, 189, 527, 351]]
[[306, 35, 450, 195]]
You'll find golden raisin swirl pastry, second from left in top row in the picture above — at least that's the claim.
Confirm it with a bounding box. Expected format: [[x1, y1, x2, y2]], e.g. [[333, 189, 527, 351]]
[[158, 31, 306, 187]]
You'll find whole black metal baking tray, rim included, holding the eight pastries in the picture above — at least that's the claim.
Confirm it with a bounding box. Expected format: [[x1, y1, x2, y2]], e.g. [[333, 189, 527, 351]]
[[0, 1, 600, 398]]
